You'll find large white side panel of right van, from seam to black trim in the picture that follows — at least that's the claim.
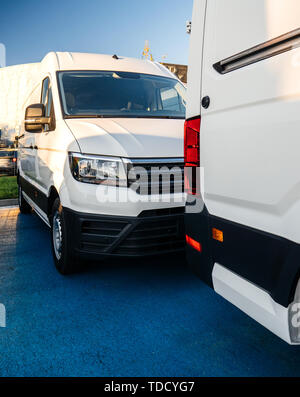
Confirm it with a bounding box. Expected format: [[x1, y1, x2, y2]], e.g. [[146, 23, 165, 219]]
[[200, 0, 300, 242]]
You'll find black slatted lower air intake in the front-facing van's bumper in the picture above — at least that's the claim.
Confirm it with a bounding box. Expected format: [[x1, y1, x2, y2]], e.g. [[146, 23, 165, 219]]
[[80, 207, 184, 256]]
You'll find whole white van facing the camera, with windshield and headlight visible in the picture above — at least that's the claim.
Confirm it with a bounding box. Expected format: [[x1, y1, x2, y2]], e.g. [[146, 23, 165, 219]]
[[4, 52, 185, 274]]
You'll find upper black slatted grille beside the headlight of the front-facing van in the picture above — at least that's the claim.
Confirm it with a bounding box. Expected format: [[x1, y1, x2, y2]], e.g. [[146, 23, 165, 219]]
[[127, 159, 184, 195]]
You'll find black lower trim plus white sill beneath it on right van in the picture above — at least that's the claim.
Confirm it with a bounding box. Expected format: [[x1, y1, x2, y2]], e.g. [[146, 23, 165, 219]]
[[185, 200, 300, 344]]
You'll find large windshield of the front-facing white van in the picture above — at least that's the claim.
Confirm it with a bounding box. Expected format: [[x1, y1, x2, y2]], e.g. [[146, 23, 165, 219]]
[[58, 71, 186, 119]]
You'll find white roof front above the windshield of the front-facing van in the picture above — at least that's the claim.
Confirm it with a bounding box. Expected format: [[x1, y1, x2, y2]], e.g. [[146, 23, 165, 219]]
[[41, 52, 176, 78]]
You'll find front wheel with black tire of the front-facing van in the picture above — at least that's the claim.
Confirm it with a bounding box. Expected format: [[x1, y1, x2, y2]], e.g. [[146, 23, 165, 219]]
[[50, 198, 80, 275]]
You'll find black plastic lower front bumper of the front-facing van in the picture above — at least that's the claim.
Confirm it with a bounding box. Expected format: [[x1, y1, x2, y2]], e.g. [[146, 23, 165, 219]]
[[64, 207, 185, 259]]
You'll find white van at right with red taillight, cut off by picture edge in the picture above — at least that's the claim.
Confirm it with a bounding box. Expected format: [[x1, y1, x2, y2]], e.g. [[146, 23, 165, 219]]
[[185, 0, 300, 344]]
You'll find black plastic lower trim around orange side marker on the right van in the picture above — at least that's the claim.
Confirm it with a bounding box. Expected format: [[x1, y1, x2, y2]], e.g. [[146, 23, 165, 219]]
[[185, 200, 300, 307]]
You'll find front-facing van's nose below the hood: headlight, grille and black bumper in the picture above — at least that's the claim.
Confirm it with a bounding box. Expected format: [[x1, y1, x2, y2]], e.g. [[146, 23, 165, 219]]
[[62, 154, 185, 259]]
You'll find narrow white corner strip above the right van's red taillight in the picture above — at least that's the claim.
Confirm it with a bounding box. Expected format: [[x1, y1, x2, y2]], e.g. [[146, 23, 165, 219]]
[[186, 0, 207, 119]]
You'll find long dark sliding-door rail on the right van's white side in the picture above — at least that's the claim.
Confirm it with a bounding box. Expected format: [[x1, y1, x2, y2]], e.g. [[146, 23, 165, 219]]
[[213, 28, 300, 74]]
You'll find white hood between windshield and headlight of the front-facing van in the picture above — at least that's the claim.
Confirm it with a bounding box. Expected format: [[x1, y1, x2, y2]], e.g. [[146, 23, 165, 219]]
[[65, 118, 184, 158]]
